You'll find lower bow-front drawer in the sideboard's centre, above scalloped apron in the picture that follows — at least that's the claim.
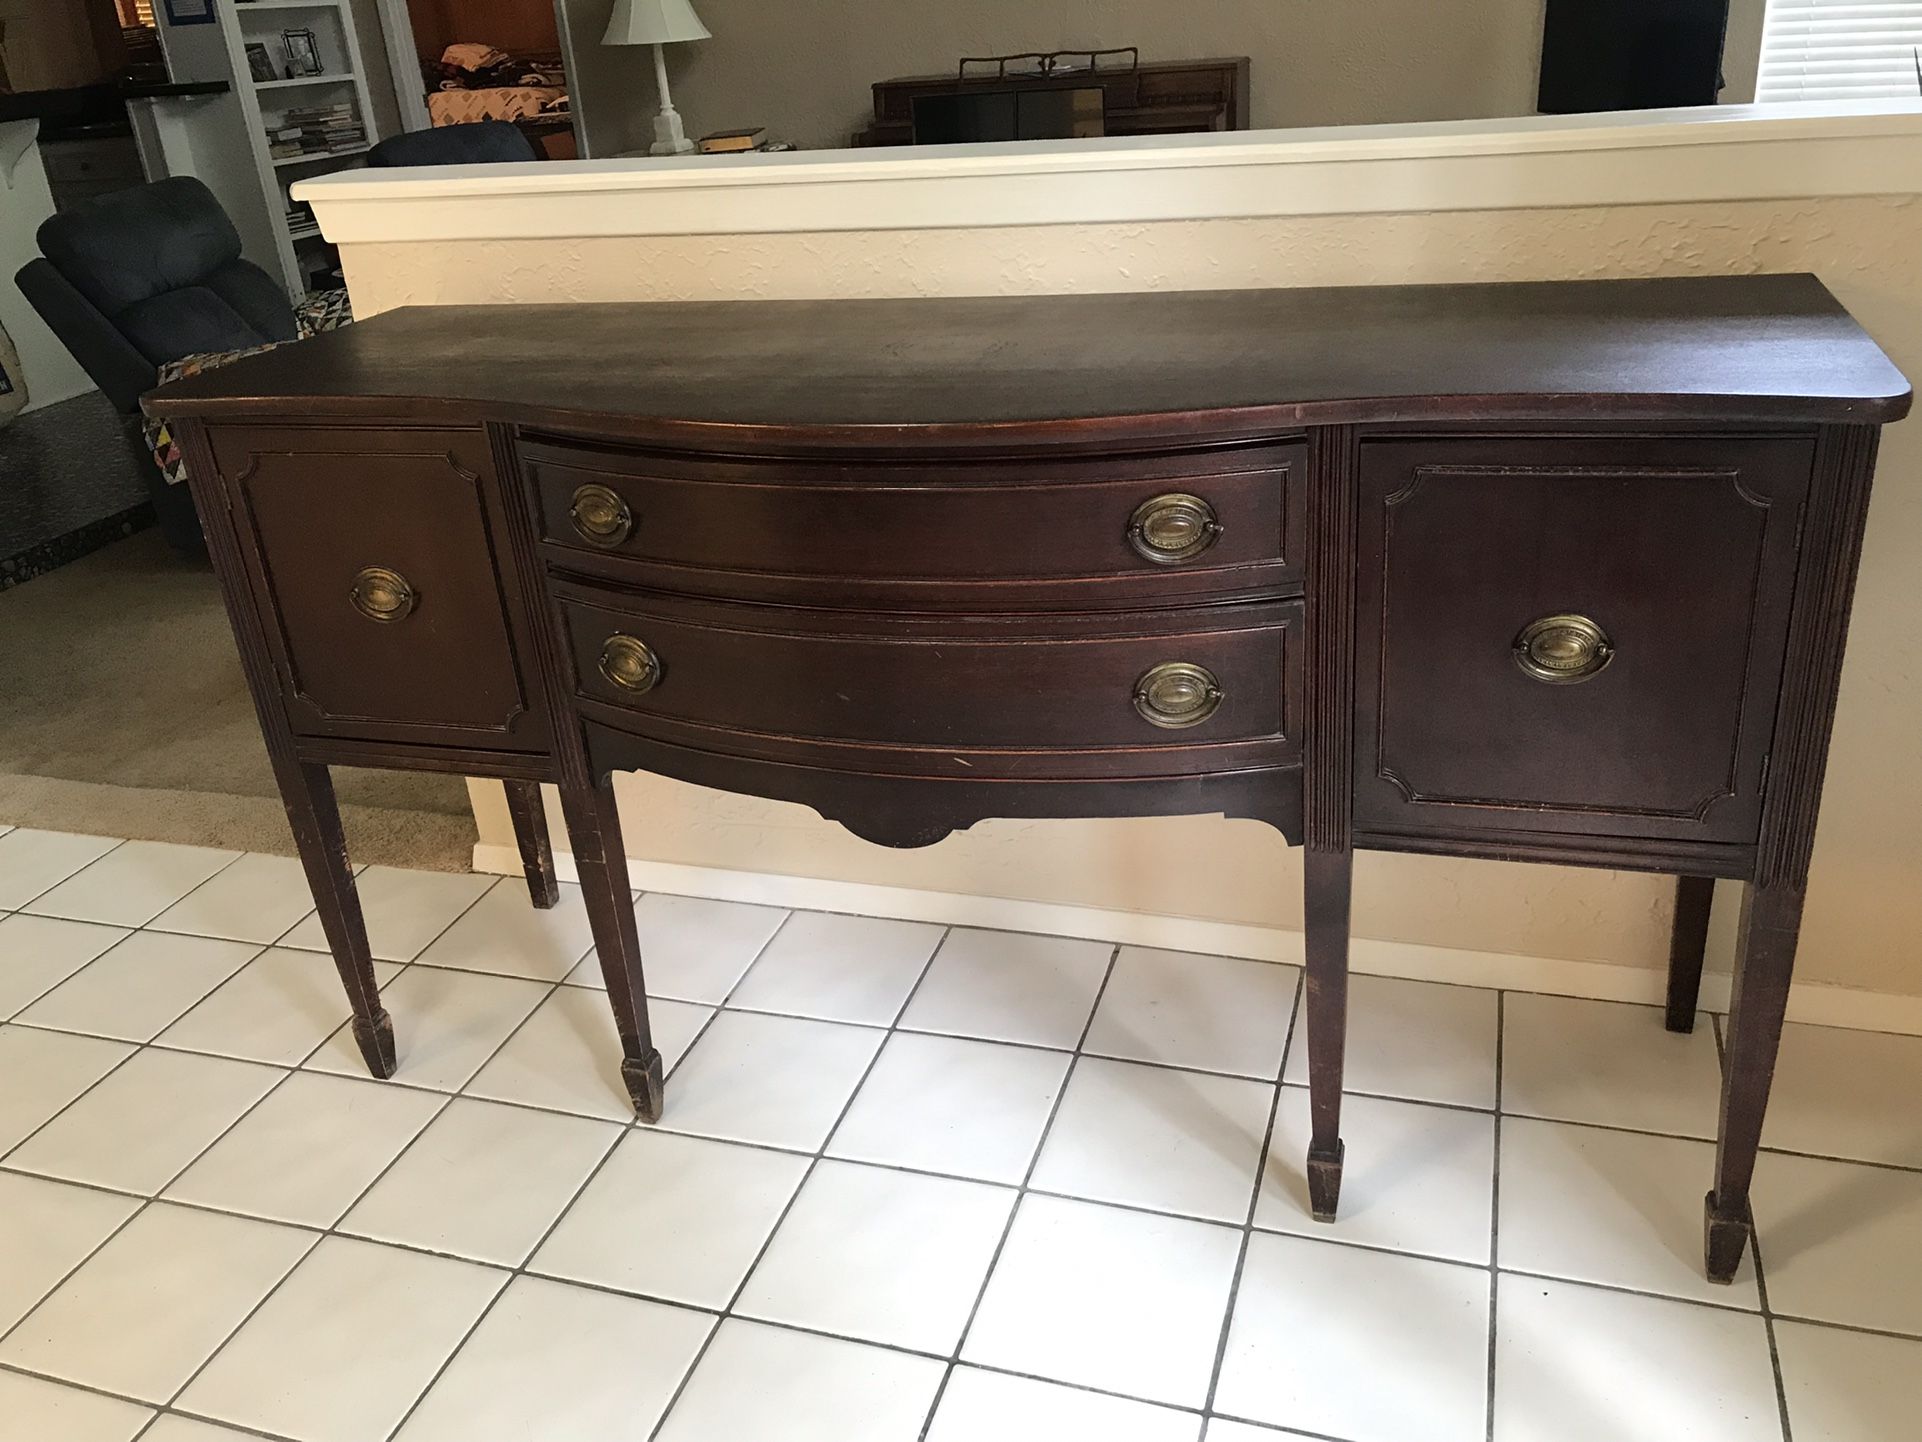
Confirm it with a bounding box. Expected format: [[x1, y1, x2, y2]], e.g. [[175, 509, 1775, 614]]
[[559, 586, 1301, 773]]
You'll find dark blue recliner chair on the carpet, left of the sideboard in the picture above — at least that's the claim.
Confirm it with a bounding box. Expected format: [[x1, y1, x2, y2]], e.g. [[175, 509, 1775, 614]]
[[13, 175, 298, 554]]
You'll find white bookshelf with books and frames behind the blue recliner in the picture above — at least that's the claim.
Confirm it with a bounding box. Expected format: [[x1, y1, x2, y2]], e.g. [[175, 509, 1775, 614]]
[[163, 0, 381, 298]]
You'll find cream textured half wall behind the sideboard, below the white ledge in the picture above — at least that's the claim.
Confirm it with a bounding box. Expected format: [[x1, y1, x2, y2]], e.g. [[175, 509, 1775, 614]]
[[346, 198, 1922, 994]]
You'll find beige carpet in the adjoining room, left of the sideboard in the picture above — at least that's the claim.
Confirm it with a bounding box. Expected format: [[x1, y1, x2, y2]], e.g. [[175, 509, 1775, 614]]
[[0, 531, 475, 871]]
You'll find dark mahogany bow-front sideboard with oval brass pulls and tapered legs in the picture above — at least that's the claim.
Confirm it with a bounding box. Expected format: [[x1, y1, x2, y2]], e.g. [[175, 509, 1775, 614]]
[[148, 275, 1909, 1280]]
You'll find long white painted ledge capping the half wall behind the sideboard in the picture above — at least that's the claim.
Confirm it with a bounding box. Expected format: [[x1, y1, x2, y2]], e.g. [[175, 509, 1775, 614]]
[[294, 102, 1922, 244]]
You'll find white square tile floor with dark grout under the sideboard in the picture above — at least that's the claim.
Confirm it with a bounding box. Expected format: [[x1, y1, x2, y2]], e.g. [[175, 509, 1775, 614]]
[[0, 827, 1922, 1442]]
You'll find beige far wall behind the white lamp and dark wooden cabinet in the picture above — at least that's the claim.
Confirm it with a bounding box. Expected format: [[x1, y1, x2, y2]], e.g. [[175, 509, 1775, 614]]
[[611, 0, 1541, 150]]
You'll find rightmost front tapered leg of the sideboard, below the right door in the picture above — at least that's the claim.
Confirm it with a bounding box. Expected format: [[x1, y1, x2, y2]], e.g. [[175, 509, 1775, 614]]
[[1705, 883, 1803, 1282]]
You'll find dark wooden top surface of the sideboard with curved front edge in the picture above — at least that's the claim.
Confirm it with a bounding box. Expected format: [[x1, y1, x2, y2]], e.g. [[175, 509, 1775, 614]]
[[146, 275, 1910, 442]]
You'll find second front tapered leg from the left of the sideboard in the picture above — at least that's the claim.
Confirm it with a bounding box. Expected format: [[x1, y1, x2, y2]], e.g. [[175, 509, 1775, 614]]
[[561, 779, 663, 1121]]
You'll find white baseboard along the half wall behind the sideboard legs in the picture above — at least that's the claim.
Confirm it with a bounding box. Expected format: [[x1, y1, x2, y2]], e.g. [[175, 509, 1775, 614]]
[[475, 842, 1922, 1036]]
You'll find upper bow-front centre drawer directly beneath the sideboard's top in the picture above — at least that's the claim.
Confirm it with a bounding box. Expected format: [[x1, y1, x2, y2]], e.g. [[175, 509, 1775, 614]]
[[521, 440, 1307, 609]]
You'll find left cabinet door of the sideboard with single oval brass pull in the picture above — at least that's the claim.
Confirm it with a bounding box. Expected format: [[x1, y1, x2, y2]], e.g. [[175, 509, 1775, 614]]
[[211, 425, 548, 752]]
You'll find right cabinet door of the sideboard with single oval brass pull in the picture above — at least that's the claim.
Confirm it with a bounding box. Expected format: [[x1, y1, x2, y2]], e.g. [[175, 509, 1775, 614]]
[[1355, 435, 1814, 844]]
